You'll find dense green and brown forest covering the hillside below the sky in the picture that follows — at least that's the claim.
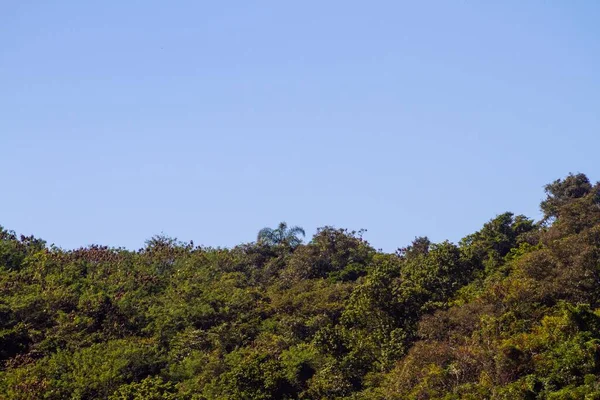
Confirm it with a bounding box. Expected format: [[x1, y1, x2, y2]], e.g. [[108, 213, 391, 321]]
[[0, 174, 600, 400]]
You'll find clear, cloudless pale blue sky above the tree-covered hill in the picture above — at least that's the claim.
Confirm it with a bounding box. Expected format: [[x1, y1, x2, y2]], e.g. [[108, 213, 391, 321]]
[[0, 0, 600, 251]]
